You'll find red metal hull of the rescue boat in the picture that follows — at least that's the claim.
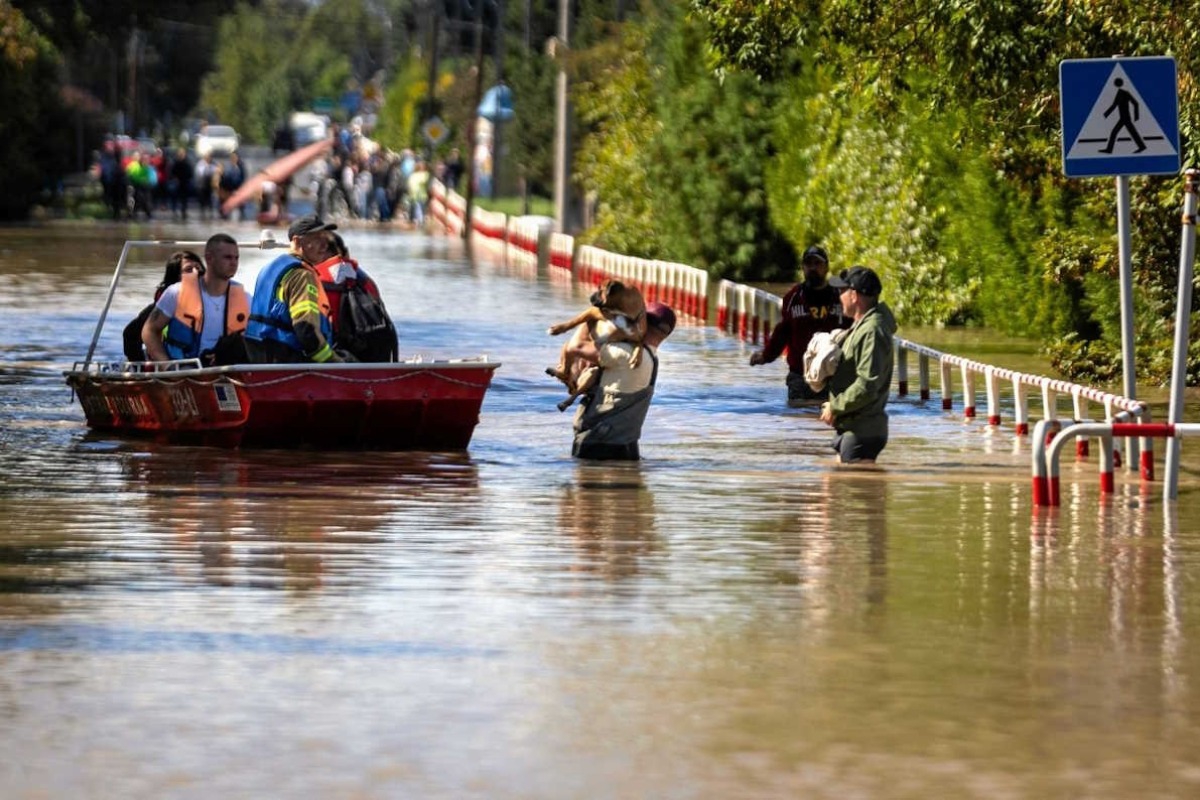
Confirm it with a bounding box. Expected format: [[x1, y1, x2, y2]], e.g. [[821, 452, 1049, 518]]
[[65, 360, 499, 450]]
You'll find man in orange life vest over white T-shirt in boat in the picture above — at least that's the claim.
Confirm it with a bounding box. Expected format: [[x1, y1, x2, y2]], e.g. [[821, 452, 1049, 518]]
[[142, 234, 251, 366]]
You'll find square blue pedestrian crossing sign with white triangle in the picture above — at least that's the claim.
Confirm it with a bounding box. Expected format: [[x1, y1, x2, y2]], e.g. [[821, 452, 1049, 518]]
[[1058, 55, 1180, 178]]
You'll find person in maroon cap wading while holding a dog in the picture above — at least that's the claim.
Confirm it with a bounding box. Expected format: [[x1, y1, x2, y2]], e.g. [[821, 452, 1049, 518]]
[[571, 302, 676, 461]]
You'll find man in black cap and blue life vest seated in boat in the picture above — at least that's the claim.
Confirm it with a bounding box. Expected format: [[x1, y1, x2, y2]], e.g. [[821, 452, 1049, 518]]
[[246, 213, 345, 363]]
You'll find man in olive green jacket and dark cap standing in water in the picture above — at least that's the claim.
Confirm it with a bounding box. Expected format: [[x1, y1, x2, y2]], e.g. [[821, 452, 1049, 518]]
[[821, 266, 896, 464]]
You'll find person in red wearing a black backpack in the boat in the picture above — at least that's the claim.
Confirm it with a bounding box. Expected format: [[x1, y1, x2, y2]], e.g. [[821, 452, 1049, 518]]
[[294, 215, 398, 362]]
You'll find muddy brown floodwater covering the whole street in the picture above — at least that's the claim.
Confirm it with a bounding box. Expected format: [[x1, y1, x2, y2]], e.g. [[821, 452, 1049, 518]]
[[0, 223, 1200, 800]]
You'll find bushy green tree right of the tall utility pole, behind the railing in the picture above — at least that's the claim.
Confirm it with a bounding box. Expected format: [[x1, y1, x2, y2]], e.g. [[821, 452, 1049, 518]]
[[576, 4, 796, 279]]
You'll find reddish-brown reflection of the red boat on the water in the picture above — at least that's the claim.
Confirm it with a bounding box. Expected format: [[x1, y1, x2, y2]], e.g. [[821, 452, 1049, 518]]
[[119, 449, 479, 591]]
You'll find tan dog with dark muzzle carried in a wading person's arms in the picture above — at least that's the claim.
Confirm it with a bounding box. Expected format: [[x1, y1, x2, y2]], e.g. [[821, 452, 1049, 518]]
[[546, 279, 646, 411]]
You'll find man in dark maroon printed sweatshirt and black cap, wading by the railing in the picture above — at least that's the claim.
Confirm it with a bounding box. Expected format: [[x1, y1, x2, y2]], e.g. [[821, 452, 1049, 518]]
[[750, 246, 851, 408]]
